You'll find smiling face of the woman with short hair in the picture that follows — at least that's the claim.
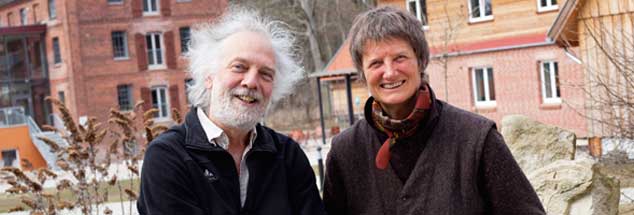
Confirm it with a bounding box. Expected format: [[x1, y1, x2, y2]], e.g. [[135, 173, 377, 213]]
[[362, 38, 421, 109]]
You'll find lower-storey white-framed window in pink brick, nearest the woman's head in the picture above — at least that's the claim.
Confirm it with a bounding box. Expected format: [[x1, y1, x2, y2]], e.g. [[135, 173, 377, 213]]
[[471, 67, 496, 107]]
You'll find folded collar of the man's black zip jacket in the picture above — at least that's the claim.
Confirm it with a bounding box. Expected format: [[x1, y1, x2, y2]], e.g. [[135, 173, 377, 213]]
[[183, 107, 277, 153]]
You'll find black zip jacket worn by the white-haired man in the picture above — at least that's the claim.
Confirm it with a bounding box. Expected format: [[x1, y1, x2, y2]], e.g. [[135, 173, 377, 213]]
[[137, 109, 325, 215]]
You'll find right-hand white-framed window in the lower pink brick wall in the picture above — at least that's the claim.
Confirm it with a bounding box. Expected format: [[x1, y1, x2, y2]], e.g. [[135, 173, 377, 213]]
[[539, 61, 561, 104]]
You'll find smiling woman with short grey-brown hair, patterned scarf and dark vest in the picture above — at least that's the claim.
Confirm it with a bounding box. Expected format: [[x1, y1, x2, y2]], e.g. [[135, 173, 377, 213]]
[[323, 7, 545, 214]]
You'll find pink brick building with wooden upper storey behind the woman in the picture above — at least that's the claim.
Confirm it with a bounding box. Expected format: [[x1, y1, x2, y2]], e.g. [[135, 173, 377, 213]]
[[324, 0, 587, 136]]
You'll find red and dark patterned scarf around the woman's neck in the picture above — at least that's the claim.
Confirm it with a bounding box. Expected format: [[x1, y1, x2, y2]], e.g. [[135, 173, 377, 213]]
[[372, 84, 431, 170]]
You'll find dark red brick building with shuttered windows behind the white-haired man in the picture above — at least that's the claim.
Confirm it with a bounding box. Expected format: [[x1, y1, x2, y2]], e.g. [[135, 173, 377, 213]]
[[0, 0, 227, 127]]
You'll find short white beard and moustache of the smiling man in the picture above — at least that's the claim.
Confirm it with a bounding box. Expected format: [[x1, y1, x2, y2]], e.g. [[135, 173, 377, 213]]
[[209, 87, 268, 131]]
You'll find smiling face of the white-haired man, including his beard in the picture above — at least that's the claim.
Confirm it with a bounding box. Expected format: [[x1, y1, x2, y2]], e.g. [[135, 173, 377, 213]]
[[206, 31, 275, 130]]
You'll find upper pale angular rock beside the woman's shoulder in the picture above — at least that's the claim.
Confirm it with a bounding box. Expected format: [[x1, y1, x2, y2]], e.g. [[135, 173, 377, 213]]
[[502, 115, 576, 173]]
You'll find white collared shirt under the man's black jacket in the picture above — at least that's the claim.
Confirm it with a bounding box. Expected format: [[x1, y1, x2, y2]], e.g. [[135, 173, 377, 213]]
[[197, 108, 257, 206]]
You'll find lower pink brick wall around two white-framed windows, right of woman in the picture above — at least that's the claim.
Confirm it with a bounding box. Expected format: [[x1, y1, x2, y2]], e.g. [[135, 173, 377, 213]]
[[427, 45, 587, 136]]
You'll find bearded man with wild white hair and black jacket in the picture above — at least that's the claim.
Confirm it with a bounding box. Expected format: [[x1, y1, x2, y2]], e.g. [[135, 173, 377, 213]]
[[137, 7, 325, 214]]
